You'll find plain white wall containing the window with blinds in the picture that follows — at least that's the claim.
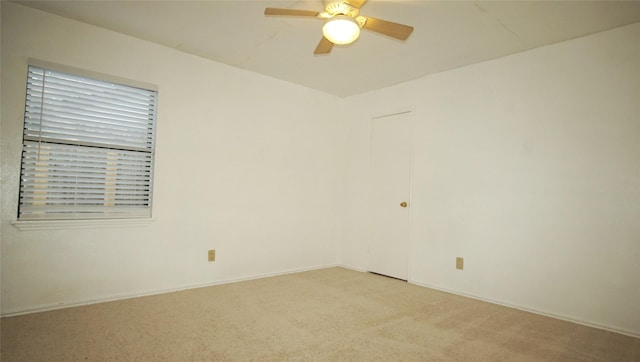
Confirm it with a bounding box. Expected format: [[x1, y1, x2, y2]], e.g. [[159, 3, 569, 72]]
[[1, 2, 345, 315]]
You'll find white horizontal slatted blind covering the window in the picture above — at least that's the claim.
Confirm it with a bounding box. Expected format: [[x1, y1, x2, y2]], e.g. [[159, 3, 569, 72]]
[[18, 66, 157, 220]]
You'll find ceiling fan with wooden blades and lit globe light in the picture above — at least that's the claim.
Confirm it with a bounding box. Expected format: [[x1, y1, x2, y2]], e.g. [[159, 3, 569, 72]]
[[264, 0, 413, 54]]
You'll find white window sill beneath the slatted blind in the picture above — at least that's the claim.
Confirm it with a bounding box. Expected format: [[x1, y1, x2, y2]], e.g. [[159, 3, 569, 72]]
[[11, 219, 154, 231]]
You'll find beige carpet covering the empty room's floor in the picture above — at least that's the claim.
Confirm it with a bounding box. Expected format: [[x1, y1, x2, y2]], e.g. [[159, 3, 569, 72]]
[[2, 268, 640, 362]]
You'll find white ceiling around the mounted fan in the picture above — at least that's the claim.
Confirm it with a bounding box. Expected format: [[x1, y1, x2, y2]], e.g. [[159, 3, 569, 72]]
[[16, 0, 640, 97]]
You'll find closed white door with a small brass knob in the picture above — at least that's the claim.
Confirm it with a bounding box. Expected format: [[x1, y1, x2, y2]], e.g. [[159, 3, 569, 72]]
[[369, 112, 412, 280]]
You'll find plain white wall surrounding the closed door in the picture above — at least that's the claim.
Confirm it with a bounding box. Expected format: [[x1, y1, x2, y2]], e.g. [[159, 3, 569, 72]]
[[340, 23, 640, 335]]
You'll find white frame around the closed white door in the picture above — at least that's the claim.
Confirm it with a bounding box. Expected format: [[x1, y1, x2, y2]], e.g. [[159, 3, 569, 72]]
[[365, 106, 416, 283]]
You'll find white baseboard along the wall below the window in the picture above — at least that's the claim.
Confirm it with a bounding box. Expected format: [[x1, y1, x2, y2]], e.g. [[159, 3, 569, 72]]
[[1, 264, 342, 318]]
